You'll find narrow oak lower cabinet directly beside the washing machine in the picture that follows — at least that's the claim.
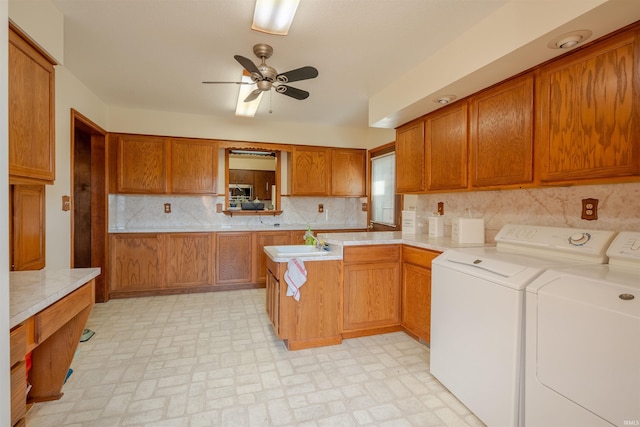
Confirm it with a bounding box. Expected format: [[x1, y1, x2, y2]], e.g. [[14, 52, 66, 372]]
[[402, 246, 440, 343]]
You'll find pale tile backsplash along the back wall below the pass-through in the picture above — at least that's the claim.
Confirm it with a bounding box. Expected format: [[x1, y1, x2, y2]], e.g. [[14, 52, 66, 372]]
[[109, 194, 367, 230]]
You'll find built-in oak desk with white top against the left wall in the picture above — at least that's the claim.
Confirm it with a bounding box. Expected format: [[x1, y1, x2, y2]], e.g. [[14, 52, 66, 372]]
[[9, 268, 100, 425]]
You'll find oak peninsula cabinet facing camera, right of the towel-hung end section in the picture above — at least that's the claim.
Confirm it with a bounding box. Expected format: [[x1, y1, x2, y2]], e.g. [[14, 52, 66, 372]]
[[343, 245, 401, 338]]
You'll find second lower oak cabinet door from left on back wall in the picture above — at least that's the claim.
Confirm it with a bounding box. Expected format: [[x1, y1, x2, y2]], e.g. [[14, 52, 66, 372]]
[[166, 233, 215, 288]]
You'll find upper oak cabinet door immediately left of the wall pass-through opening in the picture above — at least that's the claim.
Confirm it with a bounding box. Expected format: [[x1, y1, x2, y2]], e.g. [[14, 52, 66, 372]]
[[170, 139, 218, 194]]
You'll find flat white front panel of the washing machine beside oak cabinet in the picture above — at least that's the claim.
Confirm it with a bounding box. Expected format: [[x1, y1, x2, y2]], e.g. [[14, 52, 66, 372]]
[[430, 262, 524, 426]]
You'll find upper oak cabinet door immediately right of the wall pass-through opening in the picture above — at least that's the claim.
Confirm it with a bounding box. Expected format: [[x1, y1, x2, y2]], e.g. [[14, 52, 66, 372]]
[[289, 145, 331, 196]]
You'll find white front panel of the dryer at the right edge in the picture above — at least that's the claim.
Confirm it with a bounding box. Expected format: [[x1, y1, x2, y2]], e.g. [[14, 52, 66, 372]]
[[536, 275, 640, 425]]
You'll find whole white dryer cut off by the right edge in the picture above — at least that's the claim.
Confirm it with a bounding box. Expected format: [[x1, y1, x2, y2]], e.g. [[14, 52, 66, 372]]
[[525, 232, 640, 427]]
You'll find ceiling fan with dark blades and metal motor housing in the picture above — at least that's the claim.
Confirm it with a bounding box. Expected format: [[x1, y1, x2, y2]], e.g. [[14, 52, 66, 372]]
[[202, 43, 318, 102]]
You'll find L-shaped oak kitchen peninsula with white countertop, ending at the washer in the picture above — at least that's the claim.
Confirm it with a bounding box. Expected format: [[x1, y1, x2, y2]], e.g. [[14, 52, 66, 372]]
[[264, 232, 484, 350]]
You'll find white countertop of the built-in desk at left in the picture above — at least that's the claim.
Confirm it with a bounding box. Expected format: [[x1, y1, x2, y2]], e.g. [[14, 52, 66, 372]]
[[9, 268, 100, 328]]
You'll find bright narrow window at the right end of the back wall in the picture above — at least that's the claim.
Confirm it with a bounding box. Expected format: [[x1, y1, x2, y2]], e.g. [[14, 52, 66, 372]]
[[371, 152, 396, 225]]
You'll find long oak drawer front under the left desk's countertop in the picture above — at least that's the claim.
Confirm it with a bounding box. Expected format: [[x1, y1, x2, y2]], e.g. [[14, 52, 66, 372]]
[[35, 282, 93, 344]]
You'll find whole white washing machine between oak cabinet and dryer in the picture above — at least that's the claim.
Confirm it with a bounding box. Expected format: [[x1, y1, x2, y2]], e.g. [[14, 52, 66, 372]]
[[430, 224, 615, 427]]
